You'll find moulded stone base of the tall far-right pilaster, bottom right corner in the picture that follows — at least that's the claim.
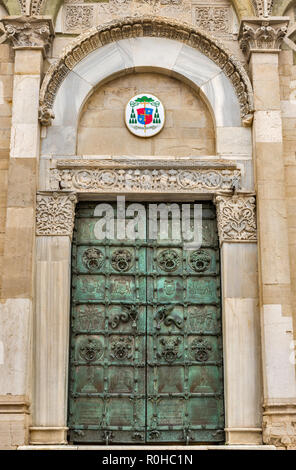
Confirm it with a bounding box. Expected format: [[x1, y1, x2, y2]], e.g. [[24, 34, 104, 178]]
[[263, 404, 296, 450]]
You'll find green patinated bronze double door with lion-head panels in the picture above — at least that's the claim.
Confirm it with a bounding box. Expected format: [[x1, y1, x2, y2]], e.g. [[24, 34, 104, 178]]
[[68, 203, 224, 444]]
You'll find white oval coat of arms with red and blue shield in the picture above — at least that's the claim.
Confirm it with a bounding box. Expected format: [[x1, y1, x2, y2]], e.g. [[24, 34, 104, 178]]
[[125, 93, 165, 137]]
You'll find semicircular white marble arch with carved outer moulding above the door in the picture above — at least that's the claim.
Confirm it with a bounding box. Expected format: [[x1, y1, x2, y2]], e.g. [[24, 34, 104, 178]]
[[40, 18, 253, 155]]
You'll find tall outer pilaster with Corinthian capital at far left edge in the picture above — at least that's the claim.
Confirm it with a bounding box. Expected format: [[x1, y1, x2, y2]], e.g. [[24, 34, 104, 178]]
[[0, 17, 52, 448]]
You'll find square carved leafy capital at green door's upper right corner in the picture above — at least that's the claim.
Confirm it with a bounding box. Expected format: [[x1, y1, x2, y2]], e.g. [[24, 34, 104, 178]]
[[215, 194, 257, 244]]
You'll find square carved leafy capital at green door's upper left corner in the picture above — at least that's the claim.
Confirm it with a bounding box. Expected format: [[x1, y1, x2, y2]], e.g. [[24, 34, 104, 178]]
[[36, 193, 77, 237]]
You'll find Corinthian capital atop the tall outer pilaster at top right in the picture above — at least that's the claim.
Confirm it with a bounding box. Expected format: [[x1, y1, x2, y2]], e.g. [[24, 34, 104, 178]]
[[239, 17, 289, 59]]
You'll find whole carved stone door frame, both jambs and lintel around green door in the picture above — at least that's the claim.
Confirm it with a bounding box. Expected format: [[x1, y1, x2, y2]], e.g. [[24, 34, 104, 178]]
[[30, 158, 262, 444]]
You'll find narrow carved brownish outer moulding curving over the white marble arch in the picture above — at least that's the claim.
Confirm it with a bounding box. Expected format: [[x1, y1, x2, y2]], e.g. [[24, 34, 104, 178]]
[[39, 17, 253, 126]]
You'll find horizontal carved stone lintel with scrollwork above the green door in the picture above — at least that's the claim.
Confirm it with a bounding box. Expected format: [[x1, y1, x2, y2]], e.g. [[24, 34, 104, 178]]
[[50, 160, 241, 194]]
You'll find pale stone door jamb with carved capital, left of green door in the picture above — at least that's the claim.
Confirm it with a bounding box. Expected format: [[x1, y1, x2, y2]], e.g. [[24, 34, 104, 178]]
[[30, 193, 76, 444]]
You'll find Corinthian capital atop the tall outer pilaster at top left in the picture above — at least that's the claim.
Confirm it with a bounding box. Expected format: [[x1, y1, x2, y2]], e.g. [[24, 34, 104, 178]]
[[2, 16, 54, 54]]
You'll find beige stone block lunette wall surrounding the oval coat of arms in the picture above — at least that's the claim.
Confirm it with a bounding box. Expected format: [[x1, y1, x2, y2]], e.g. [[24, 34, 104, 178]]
[[77, 73, 215, 157]]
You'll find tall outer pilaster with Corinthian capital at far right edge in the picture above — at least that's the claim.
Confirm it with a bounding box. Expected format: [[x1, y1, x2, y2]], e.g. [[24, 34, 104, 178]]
[[240, 17, 296, 448]]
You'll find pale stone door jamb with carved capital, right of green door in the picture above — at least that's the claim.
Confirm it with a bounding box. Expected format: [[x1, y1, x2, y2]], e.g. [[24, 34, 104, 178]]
[[215, 192, 262, 444]]
